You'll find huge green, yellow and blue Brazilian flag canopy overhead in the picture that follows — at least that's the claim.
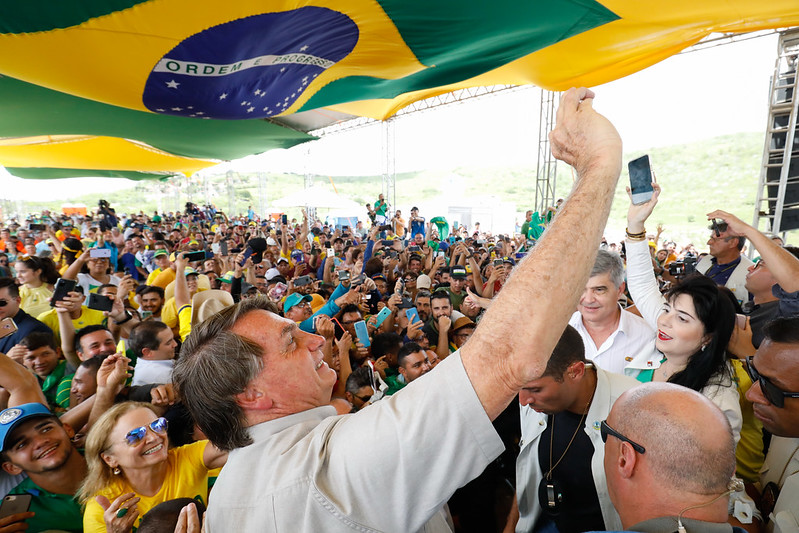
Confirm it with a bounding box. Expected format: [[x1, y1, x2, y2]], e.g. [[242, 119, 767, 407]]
[[0, 0, 799, 177]]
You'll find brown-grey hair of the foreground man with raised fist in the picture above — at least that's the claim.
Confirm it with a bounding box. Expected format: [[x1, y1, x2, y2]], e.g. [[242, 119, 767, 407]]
[[172, 296, 279, 451]]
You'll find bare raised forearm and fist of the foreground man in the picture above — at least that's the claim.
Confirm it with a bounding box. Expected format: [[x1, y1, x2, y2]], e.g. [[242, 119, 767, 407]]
[[461, 88, 621, 420]]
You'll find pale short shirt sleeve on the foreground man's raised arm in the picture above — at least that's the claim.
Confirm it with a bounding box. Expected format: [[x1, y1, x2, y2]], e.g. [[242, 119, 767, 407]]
[[316, 353, 504, 531]]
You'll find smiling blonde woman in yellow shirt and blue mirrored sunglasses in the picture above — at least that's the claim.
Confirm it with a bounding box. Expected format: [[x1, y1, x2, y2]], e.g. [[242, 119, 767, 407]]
[[78, 402, 227, 533]]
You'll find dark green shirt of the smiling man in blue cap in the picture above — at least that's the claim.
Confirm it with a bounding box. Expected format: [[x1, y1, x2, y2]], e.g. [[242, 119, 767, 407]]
[[9, 476, 83, 533]]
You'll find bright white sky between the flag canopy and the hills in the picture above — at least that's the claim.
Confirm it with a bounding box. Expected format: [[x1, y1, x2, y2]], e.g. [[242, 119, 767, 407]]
[[0, 31, 777, 200]]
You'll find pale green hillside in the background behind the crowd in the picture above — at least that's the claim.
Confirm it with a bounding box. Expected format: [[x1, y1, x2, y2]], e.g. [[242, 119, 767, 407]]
[[14, 133, 776, 243]]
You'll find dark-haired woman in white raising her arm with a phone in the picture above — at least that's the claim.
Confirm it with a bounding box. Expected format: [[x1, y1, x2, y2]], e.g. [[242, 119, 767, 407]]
[[624, 184, 741, 444]]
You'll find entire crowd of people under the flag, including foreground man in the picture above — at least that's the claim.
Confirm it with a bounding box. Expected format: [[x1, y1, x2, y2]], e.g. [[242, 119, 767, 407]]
[[0, 89, 799, 533]]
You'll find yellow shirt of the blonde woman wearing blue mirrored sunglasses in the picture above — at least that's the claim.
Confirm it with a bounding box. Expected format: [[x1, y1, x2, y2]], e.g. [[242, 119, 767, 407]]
[[83, 440, 209, 533]]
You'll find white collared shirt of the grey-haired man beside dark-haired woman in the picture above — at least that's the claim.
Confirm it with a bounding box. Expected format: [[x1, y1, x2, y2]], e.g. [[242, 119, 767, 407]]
[[569, 309, 655, 374]]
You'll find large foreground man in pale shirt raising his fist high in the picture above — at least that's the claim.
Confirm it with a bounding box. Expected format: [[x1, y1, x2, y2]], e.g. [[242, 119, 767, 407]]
[[173, 89, 621, 533]]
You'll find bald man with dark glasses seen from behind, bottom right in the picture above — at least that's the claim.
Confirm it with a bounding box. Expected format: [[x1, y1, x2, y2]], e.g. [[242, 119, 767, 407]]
[[601, 383, 740, 533]]
